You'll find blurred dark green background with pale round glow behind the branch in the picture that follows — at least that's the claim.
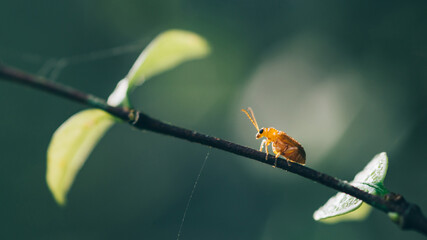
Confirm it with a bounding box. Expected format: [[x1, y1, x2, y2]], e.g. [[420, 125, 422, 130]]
[[0, 0, 427, 240]]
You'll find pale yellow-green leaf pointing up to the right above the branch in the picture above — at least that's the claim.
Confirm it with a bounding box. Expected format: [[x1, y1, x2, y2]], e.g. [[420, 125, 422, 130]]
[[126, 30, 210, 88]]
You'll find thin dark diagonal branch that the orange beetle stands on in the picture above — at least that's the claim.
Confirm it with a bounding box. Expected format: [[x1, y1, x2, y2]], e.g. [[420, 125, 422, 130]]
[[0, 65, 427, 236]]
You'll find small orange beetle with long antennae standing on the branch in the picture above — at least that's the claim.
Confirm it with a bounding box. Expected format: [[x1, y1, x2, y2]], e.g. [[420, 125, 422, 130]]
[[242, 107, 306, 167]]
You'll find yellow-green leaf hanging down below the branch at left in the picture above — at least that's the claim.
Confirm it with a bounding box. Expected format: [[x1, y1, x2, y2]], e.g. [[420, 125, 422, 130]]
[[46, 109, 117, 205]]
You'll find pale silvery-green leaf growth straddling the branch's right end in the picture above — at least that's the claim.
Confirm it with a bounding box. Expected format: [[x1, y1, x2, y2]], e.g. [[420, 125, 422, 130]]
[[313, 152, 388, 223]]
